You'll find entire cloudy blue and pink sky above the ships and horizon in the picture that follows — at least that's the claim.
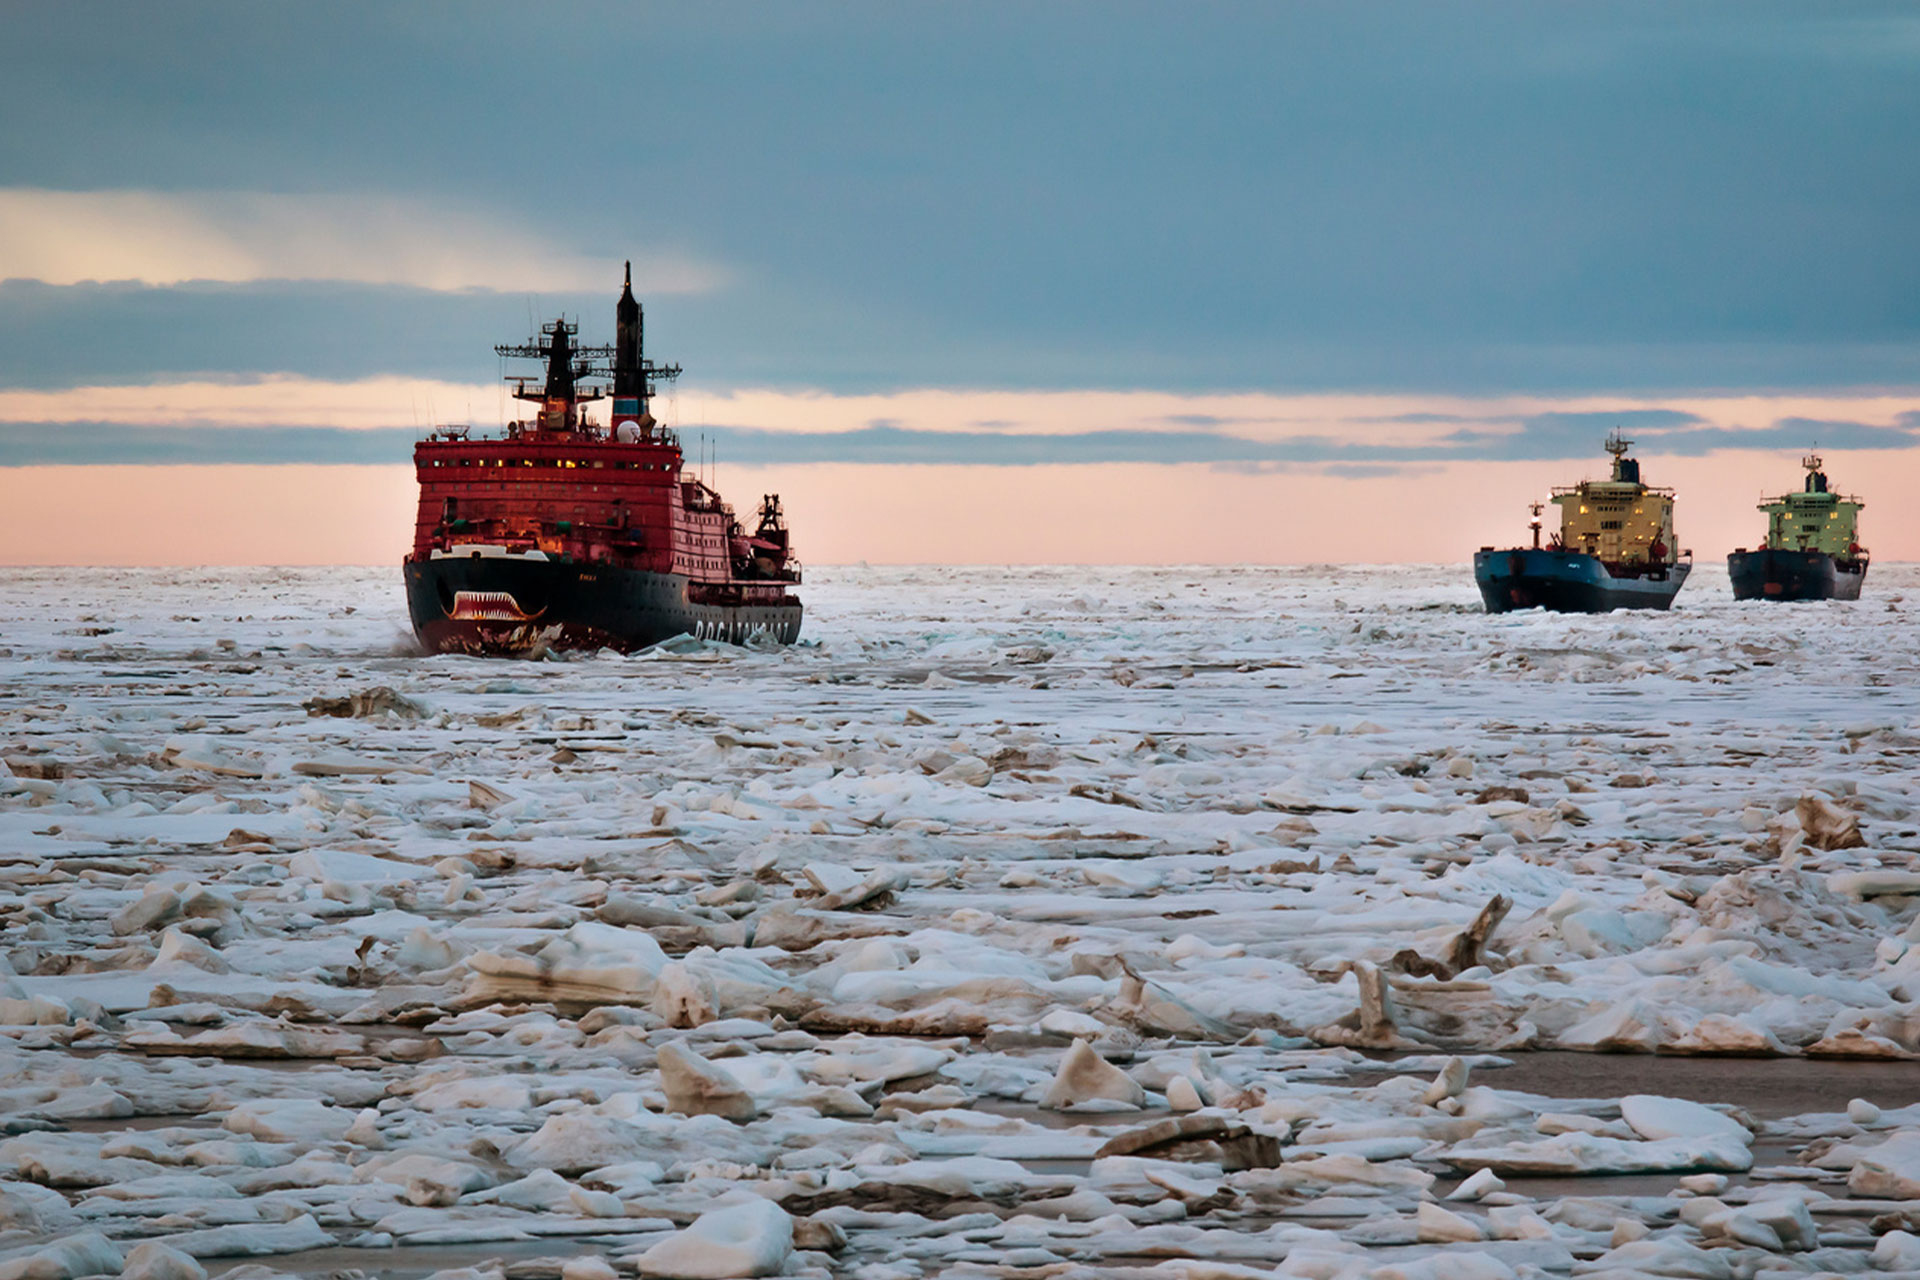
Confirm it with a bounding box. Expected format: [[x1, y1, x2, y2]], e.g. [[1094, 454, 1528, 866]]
[[0, 0, 1920, 564]]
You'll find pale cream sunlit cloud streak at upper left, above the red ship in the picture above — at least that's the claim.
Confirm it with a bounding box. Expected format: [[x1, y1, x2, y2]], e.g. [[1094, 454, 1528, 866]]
[[0, 186, 724, 294]]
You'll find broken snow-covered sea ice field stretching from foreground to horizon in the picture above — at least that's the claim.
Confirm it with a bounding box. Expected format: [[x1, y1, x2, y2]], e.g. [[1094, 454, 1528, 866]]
[[0, 564, 1920, 1280]]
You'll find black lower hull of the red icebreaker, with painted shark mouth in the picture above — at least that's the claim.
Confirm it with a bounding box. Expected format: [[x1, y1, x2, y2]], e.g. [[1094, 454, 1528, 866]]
[[405, 557, 803, 656]]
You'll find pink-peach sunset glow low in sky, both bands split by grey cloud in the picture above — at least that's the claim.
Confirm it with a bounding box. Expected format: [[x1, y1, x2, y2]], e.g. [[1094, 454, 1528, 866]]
[[0, 376, 1920, 566]]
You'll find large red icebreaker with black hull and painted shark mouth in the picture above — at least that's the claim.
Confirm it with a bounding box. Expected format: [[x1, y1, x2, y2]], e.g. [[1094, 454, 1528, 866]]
[[403, 263, 803, 654]]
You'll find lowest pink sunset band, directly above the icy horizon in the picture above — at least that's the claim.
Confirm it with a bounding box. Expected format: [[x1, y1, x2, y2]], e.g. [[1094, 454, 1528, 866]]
[[0, 451, 1920, 574]]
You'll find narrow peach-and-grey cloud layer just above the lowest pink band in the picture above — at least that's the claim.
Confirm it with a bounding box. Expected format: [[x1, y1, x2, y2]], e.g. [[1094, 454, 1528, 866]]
[[0, 385, 1920, 478]]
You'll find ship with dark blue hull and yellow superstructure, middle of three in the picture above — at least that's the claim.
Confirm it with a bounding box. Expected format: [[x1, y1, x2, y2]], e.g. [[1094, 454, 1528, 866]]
[[1473, 432, 1693, 614]]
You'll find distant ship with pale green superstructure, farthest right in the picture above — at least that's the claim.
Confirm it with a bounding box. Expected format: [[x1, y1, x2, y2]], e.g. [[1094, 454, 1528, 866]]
[[1726, 453, 1868, 601]]
